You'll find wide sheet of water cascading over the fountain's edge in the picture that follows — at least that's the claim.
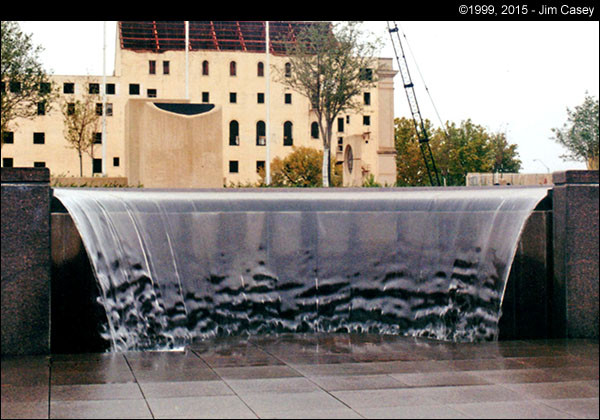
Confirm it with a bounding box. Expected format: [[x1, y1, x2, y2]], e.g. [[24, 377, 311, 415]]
[[54, 187, 548, 351]]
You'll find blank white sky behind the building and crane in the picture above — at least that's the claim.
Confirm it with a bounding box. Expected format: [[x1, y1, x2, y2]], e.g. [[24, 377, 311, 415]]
[[19, 21, 600, 173]]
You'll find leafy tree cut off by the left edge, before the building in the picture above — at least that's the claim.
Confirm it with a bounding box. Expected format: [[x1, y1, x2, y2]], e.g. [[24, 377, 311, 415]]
[[0, 21, 56, 145]]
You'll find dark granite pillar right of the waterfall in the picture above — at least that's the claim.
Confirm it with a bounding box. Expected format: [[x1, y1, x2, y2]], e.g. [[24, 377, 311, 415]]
[[552, 171, 599, 338]]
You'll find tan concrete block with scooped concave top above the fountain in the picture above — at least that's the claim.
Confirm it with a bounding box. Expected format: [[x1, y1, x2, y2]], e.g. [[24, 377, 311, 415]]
[[125, 99, 223, 188]]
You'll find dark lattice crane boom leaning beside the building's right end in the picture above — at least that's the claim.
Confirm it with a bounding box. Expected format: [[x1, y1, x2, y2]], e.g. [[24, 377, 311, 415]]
[[387, 21, 442, 186]]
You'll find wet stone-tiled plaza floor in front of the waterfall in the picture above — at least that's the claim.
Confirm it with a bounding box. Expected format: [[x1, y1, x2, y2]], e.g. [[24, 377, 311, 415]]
[[1, 334, 599, 419]]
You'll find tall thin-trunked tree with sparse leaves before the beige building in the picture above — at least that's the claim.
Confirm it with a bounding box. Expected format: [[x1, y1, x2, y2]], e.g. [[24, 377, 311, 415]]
[[275, 22, 379, 187]]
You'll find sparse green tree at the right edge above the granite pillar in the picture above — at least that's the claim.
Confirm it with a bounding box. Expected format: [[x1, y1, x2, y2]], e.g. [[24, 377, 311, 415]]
[[552, 93, 598, 170]]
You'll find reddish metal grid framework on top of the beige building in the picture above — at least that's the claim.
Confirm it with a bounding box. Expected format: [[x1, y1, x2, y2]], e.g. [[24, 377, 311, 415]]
[[119, 21, 324, 55]]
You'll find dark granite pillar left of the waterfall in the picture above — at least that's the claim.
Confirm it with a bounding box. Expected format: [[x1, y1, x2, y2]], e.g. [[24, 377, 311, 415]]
[[1, 168, 50, 355]]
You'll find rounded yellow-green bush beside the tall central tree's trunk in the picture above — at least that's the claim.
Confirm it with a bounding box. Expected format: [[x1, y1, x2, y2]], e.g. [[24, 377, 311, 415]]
[[260, 146, 342, 187]]
